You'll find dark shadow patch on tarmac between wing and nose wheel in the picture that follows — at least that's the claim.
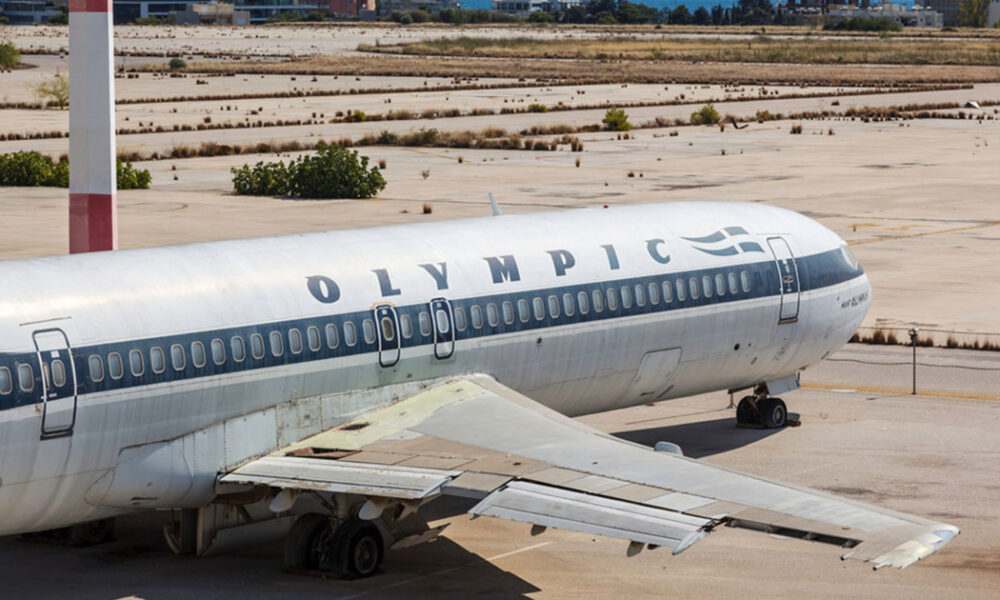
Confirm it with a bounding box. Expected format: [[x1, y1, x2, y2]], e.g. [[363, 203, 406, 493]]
[[612, 414, 797, 458]]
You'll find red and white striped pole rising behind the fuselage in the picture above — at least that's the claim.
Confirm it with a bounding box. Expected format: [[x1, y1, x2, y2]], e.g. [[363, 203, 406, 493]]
[[69, 0, 118, 253]]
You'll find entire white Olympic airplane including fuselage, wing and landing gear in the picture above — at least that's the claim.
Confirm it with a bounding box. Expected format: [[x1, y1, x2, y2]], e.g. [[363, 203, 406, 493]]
[[0, 202, 959, 578]]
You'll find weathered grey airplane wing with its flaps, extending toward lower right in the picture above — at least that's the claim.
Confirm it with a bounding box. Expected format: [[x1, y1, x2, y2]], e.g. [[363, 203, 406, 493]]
[[222, 375, 959, 569]]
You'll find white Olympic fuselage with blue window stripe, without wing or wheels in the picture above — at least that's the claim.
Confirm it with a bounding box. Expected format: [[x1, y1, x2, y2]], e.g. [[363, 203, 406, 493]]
[[0, 203, 870, 534]]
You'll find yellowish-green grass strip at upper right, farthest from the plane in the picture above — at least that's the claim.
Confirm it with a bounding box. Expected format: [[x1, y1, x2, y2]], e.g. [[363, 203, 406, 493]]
[[370, 36, 1000, 66]]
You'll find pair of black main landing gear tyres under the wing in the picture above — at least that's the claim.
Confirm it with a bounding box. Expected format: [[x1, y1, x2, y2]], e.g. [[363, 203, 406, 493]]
[[285, 513, 385, 579]]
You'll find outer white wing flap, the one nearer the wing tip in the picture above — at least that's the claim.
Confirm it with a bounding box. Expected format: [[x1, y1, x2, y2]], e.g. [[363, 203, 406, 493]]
[[469, 481, 714, 554]]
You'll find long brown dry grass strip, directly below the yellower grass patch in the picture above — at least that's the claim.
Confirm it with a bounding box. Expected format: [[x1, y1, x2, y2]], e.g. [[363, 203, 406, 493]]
[[178, 56, 1000, 86]]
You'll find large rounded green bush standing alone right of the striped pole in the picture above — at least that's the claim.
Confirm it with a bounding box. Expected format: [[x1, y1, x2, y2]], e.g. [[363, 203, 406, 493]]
[[232, 144, 385, 198]]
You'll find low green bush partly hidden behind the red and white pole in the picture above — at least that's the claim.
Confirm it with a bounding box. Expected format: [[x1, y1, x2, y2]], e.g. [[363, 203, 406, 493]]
[[0, 151, 152, 190]]
